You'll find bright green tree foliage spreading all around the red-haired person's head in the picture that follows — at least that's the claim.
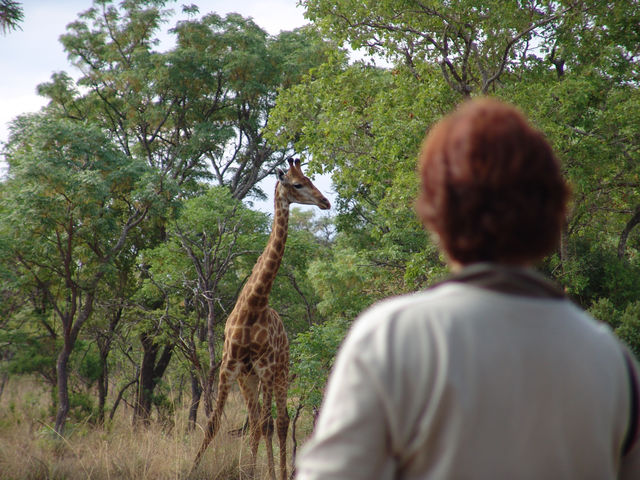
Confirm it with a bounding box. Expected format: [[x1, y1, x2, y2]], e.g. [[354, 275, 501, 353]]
[[270, 0, 640, 318]]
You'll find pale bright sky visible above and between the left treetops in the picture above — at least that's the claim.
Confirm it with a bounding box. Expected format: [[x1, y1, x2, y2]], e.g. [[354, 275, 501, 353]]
[[0, 0, 332, 208]]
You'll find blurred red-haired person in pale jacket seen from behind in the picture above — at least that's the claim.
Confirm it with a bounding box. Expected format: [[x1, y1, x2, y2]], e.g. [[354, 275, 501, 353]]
[[297, 98, 640, 480]]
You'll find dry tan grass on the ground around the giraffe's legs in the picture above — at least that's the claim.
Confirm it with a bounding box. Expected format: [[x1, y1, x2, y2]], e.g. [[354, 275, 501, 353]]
[[0, 379, 310, 480]]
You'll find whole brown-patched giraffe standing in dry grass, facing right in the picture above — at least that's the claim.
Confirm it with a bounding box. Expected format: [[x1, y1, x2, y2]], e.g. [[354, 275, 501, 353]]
[[193, 158, 331, 480]]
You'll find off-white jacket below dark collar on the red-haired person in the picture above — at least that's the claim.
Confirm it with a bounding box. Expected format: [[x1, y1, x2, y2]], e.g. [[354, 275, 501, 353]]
[[297, 266, 640, 480]]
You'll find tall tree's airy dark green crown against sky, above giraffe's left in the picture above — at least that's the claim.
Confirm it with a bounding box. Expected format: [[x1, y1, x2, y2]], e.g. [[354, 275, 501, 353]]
[[46, 0, 330, 199]]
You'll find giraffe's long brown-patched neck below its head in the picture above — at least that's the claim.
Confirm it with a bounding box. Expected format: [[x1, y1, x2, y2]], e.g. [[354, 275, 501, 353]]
[[242, 185, 289, 310]]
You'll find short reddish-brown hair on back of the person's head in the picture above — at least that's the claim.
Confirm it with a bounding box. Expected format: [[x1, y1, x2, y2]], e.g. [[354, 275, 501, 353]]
[[417, 98, 568, 264]]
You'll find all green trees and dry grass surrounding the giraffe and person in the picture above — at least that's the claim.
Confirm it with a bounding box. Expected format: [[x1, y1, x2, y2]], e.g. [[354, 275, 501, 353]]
[[0, 0, 640, 478]]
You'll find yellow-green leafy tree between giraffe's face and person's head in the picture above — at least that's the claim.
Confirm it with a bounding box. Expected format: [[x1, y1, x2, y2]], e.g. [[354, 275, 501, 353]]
[[269, 59, 450, 300]]
